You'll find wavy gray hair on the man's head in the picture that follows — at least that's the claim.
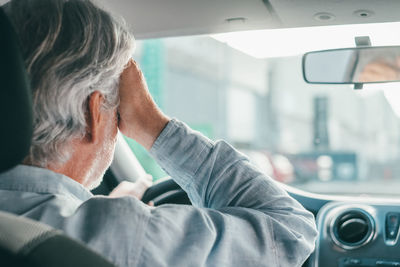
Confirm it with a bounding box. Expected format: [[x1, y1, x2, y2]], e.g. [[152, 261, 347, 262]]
[[6, 0, 134, 167]]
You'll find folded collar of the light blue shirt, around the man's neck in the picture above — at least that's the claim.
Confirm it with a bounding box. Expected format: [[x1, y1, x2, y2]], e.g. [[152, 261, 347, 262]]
[[0, 165, 93, 201]]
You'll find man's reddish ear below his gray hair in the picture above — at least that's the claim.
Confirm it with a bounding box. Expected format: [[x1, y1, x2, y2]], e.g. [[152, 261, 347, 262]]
[[86, 91, 104, 143]]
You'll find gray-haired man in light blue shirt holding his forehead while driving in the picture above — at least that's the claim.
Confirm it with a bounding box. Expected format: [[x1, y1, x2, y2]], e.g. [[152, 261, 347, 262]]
[[0, 0, 317, 266]]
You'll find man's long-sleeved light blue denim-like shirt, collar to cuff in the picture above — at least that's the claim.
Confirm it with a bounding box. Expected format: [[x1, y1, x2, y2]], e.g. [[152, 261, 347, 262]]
[[0, 120, 317, 267]]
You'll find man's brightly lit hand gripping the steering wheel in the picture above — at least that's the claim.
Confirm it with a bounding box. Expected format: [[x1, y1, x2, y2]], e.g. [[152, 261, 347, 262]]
[[109, 175, 154, 206]]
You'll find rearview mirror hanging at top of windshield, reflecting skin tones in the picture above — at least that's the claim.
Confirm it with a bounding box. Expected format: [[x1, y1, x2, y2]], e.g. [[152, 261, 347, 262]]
[[303, 46, 400, 84]]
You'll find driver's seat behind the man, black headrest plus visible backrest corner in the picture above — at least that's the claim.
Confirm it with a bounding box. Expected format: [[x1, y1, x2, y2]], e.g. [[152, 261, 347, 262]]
[[0, 8, 114, 267]]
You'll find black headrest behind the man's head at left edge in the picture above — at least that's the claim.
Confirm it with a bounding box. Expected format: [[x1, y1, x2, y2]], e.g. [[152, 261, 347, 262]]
[[0, 8, 32, 172]]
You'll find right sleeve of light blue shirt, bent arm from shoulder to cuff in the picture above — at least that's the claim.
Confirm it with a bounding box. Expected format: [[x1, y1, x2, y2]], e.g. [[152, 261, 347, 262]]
[[139, 120, 317, 266]]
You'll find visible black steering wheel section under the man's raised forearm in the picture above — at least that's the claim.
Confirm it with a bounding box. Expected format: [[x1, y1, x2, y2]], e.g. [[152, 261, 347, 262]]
[[142, 179, 192, 206]]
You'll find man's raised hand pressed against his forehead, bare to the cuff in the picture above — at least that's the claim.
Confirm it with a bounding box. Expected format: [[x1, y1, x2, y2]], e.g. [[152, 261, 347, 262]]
[[118, 60, 169, 150]]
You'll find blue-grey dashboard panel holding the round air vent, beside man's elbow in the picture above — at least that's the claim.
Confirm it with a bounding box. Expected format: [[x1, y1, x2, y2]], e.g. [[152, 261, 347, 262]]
[[310, 202, 400, 267]]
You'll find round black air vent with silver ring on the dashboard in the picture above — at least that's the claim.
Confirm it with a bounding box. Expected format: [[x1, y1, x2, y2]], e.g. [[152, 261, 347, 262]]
[[331, 209, 375, 249]]
